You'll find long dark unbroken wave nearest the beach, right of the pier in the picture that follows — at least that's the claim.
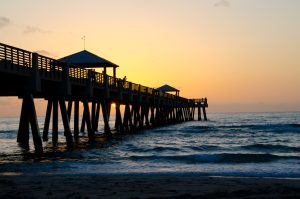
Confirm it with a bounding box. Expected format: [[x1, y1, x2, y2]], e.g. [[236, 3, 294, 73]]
[[129, 153, 300, 164]]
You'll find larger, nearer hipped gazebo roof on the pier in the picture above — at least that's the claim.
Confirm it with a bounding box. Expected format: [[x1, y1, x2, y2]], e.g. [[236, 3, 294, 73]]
[[59, 50, 119, 68]]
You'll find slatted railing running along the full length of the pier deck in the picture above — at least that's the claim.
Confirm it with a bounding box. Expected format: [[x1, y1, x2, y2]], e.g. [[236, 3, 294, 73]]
[[0, 43, 207, 104]]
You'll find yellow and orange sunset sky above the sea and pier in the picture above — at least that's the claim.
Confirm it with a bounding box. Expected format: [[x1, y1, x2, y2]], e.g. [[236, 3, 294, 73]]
[[0, 0, 300, 116]]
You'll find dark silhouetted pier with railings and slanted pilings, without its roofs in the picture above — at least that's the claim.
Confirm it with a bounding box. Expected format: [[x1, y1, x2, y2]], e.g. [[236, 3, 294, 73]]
[[0, 43, 208, 154]]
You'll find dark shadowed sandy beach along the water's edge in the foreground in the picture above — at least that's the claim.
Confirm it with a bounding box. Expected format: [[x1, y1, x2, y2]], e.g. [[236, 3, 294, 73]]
[[0, 175, 300, 199]]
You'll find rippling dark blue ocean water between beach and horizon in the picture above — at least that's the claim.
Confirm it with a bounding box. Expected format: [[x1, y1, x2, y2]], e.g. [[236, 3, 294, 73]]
[[0, 112, 300, 178]]
